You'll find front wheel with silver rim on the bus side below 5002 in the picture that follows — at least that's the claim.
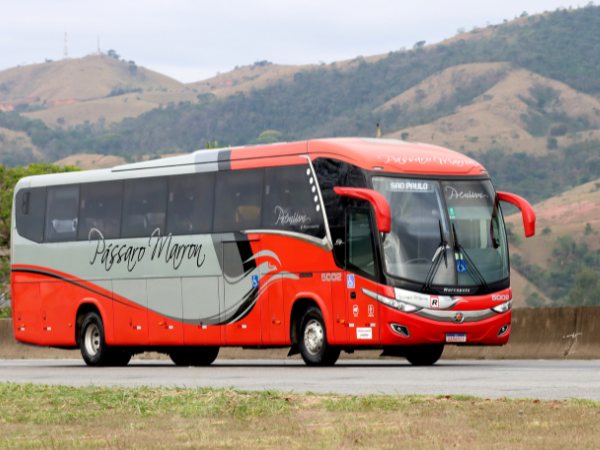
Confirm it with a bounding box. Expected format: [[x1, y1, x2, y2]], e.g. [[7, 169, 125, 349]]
[[298, 306, 341, 366]]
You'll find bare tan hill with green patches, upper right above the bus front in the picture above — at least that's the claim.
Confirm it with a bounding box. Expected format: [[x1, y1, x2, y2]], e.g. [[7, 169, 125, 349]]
[[392, 63, 600, 154]]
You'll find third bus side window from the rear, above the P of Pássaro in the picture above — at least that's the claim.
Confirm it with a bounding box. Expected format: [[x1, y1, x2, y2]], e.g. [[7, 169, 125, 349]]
[[77, 182, 123, 239]]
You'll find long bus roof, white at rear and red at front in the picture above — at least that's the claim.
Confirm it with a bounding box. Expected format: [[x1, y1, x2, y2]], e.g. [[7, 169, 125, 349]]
[[19, 138, 487, 187]]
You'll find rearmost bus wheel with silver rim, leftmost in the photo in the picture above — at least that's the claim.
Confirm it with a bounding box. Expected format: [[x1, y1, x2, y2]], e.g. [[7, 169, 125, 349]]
[[79, 312, 132, 366]]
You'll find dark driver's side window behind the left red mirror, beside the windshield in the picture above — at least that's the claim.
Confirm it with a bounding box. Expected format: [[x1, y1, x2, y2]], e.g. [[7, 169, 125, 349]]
[[346, 210, 375, 276]]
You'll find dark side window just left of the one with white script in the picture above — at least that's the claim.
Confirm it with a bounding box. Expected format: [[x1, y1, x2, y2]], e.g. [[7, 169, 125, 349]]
[[214, 170, 263, 232]]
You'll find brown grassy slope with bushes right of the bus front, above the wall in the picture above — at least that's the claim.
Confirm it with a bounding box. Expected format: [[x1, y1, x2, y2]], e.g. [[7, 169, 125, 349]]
[[507, 178, 600, 306]]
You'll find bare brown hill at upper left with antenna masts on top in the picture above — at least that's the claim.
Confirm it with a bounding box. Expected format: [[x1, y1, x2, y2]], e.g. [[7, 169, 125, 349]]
[[0, 55, 197, 126]]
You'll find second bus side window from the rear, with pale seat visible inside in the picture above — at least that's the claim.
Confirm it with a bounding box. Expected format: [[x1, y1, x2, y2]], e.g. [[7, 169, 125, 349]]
[[45, 186, 79, 242]]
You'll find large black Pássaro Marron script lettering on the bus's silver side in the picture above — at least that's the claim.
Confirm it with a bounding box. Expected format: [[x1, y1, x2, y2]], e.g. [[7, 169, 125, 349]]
[[88, 228, 206, 272]]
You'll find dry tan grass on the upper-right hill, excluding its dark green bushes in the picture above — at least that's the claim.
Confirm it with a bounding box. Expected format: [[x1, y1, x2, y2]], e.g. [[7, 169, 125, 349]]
[[389, 68, 600, 154]]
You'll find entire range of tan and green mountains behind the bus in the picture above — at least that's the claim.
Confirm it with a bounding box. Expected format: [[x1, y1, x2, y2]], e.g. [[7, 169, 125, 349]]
[[0, 4, 600, 305]]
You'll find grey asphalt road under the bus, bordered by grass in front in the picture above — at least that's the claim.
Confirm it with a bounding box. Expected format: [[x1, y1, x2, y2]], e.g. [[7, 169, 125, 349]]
[[0, 359, 600, 400]]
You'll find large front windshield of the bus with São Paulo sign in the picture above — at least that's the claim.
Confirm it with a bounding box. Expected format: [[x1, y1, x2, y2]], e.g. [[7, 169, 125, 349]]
[[373, 176, 508, 290]]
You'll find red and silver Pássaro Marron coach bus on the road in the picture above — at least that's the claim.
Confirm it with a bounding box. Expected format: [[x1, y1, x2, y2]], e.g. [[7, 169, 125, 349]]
[[11, 138, 535, 365]]
